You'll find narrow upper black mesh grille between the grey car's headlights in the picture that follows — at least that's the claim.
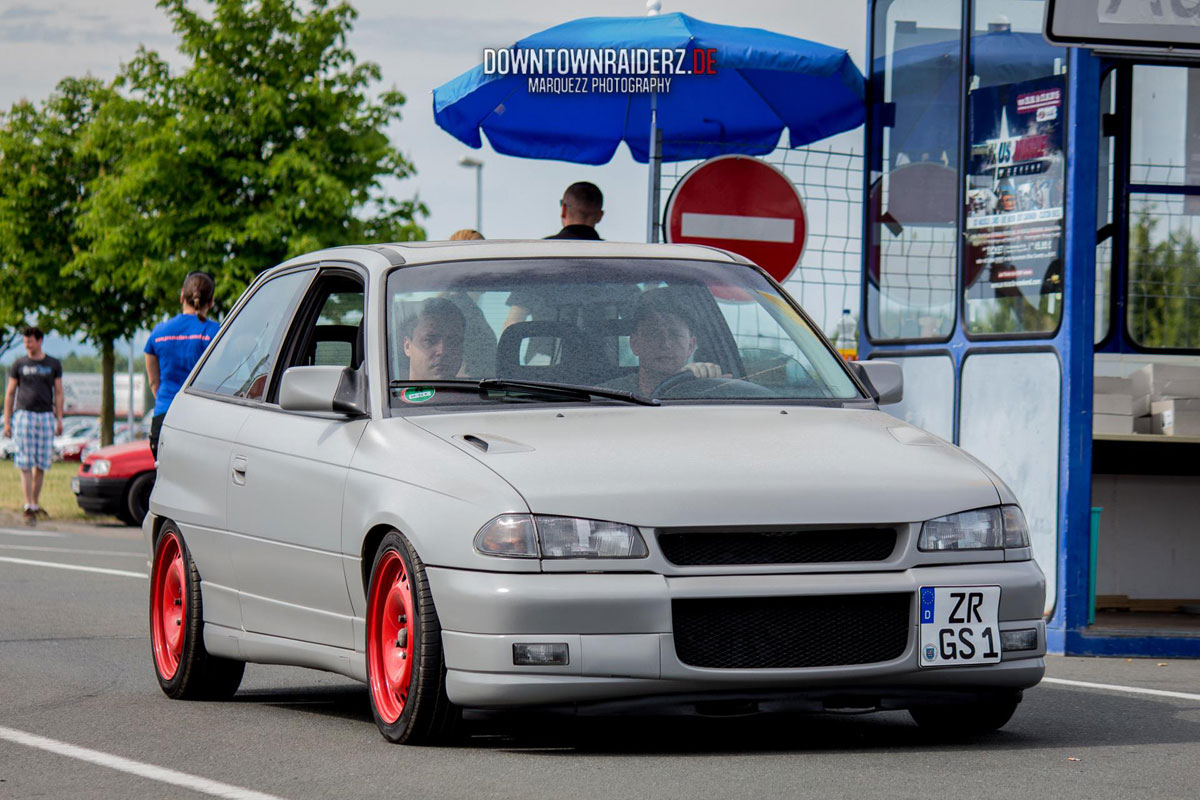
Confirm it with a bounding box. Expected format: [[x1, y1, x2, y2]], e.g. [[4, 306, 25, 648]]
[[659, 528, 896, 566]]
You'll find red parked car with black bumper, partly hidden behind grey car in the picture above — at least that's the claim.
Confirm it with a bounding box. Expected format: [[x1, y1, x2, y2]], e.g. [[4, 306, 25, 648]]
[[71, 439, 155, 525]]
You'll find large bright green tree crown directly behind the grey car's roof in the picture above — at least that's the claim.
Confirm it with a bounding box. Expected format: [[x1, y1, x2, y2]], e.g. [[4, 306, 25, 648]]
[[74, 0, 425, 309]]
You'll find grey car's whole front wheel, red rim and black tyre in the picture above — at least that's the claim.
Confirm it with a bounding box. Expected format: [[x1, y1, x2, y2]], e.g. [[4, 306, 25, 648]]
[[366, 531, 461, 745]]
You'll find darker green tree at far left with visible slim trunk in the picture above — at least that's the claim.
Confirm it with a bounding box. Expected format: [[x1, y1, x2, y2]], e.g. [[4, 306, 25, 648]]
[[0, 78, 157, 444]]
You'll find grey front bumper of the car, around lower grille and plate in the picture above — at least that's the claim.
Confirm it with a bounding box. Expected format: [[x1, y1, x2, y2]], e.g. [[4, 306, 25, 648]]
[[427, 561, 1045, 709]]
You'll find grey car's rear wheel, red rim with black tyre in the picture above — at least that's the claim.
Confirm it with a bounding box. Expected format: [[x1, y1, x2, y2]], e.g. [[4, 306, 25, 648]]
[[150, 522, 246, 700]]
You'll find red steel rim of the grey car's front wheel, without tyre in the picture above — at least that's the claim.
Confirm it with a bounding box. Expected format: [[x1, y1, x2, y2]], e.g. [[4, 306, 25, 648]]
[[367, 551, 414, 723]]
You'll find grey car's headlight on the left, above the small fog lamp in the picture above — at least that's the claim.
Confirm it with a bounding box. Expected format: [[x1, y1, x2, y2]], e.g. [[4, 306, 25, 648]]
[[475, 513, 649, 559]]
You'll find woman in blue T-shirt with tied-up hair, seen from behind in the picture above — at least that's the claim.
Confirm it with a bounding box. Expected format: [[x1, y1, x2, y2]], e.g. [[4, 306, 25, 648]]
[[144, 272, 221, 458]]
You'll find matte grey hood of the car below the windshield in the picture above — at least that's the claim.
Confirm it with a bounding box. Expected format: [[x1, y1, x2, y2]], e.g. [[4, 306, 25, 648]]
[[408, 405, 998, 527]]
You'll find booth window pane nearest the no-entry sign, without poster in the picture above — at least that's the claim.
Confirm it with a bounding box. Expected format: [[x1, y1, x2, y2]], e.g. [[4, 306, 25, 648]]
[[866, 0, 962, 341]]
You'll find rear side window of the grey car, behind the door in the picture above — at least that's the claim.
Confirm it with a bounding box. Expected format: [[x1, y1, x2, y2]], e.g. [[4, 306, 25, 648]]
[[192, 270, 312, 399]]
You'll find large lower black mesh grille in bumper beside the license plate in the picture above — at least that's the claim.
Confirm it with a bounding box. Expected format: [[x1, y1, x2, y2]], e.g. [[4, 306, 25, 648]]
[[671, 594, 912, 669]]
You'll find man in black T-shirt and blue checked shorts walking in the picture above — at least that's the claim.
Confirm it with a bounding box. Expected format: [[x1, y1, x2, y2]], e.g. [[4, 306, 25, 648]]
[[4, 326, 62, 524]]
